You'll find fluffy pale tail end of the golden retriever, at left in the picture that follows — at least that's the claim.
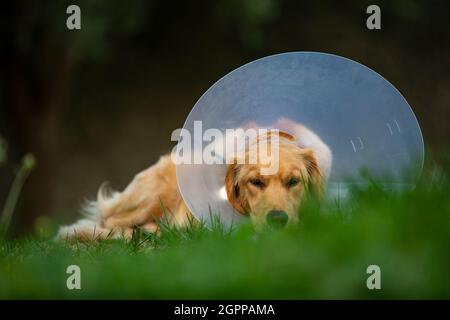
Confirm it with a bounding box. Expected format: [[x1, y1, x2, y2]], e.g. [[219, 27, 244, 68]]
[[55, 183, 120, 241]]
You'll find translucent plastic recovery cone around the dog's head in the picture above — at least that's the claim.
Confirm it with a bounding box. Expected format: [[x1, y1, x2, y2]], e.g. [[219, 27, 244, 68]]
[[177, 52, 424, 223]]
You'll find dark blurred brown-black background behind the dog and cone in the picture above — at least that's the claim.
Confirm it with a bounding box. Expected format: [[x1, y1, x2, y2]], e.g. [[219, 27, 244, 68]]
[[0, 0, 450, 234]]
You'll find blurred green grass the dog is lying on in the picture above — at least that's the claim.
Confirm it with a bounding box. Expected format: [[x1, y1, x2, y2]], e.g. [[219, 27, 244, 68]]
[[0, 171, 450, 299]]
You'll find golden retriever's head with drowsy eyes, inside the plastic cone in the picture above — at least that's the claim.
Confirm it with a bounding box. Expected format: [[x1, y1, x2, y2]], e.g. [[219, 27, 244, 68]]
[[225, 132, 324, 229]]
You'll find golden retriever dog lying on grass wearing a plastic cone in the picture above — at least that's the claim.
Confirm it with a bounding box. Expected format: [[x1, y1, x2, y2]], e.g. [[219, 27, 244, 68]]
[[57, 119, 332, 240]]
